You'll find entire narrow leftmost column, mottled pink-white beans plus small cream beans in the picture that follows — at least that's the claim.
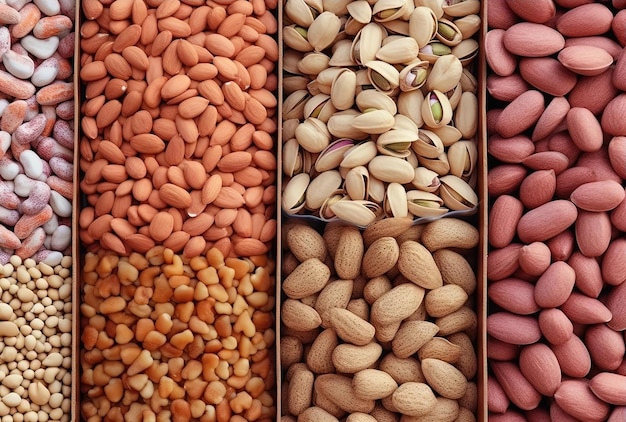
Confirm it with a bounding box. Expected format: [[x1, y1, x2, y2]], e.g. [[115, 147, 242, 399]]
[[0, 0, 76, 422]]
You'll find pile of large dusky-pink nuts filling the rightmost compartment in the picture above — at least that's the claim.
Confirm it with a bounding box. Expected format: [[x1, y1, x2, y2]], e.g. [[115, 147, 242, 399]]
[[485, 0, 626, 422]]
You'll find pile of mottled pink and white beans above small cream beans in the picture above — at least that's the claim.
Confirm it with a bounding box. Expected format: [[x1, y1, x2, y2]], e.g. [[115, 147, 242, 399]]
[[0, 0, 76, 265]]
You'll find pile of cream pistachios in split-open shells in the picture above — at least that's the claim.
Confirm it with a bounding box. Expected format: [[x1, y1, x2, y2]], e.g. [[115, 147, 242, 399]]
[[282, 0, 480, 226]]
